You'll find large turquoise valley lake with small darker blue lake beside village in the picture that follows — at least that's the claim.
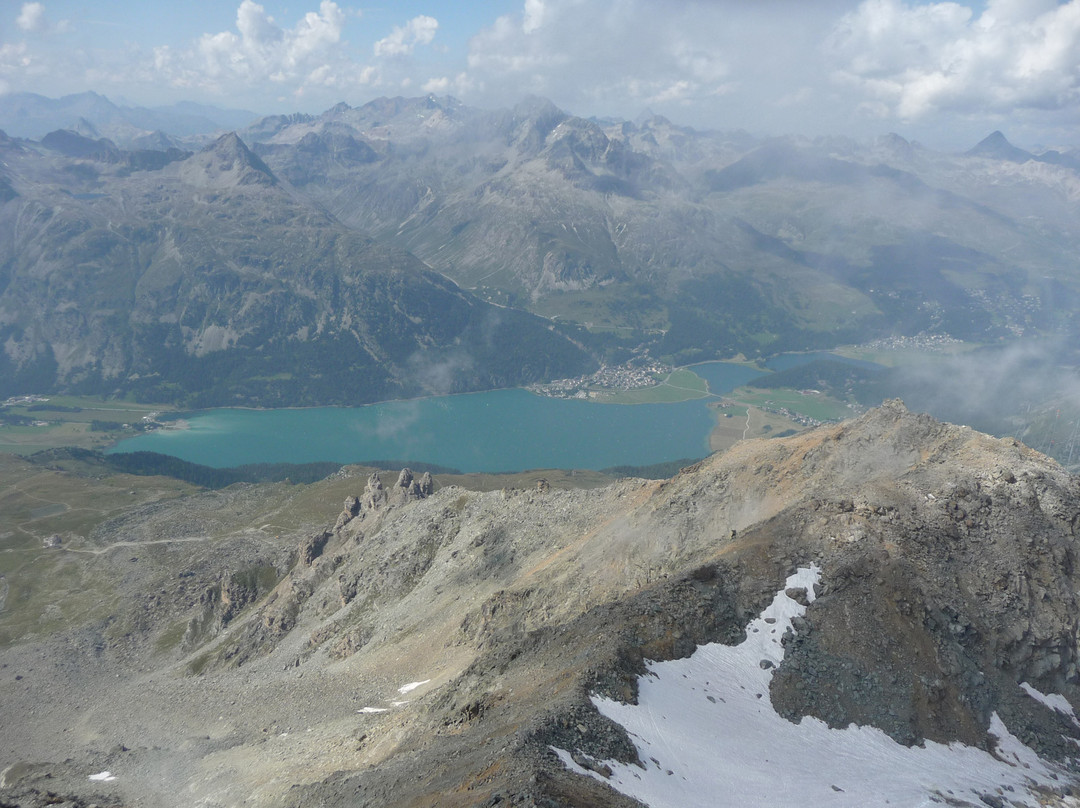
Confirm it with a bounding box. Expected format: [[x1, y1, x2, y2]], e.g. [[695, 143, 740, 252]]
[[105, 362, 803, 472]]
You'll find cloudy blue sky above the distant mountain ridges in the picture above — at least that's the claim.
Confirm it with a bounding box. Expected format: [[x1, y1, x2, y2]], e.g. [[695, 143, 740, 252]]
[[0, 0, 1080, 148]]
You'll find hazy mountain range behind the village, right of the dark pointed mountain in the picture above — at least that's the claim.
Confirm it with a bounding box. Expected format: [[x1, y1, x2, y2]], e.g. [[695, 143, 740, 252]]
[[244, 97, 1078, 359]]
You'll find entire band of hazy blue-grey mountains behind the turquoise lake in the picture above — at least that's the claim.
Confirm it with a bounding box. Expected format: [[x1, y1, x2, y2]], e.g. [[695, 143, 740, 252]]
[[0, 96, 1080, 405]]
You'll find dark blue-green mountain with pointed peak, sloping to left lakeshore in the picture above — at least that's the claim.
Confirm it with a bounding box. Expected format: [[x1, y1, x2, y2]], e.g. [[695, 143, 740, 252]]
[[0, 124, 592, 406]]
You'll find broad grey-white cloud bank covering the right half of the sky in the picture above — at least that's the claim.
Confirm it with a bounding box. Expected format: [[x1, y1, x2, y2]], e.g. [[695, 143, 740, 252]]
[[446, 0, 1080, 147]]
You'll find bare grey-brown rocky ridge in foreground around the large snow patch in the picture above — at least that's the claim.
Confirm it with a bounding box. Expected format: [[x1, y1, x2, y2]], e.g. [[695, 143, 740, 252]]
[[0, 403, 1080, 808]]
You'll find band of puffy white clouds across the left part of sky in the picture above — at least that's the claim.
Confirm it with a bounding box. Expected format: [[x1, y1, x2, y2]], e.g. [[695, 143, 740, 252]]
[[0, 0, 449, 111]]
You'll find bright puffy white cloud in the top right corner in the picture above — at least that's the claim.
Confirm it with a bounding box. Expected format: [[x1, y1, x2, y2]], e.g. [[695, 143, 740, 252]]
[[827, 0, 1080, 120]]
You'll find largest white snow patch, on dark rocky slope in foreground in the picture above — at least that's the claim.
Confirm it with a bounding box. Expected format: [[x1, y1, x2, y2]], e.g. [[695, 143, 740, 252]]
[[554, 567, 1071, 808]]
